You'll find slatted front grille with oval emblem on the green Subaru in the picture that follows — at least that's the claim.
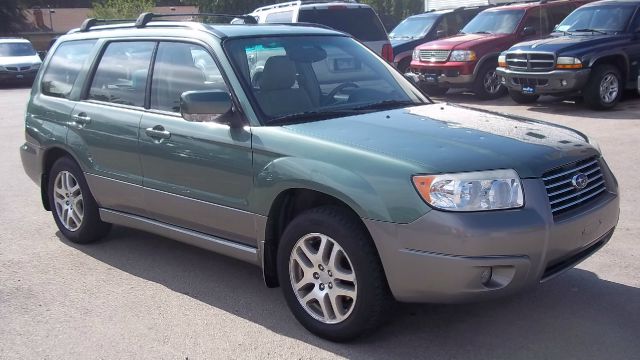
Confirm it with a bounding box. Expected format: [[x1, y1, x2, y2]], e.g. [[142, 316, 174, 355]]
[[543, 158, 606, 216]]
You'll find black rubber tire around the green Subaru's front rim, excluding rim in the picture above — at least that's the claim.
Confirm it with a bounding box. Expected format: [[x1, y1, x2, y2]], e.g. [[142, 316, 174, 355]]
[[277, 206, 393, 341]]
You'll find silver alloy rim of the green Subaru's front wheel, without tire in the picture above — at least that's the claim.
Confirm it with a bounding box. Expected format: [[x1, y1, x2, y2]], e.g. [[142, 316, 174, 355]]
[[289, 233, 358, 324]]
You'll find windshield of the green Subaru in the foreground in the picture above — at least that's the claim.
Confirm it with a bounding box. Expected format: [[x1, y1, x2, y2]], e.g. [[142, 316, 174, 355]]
[[224, 36, 428, 124]]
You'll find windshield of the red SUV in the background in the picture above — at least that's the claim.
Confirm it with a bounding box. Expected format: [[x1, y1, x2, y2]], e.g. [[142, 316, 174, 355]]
[[461, 10, 524, 34]]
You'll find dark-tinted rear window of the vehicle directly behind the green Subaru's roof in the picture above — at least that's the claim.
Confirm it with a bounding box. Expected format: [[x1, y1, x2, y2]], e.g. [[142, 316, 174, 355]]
[[298, 7, 388, 41]]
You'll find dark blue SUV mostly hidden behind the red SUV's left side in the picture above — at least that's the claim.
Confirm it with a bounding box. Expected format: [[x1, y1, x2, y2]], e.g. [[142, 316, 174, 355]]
[[389, 6, 489, 73]]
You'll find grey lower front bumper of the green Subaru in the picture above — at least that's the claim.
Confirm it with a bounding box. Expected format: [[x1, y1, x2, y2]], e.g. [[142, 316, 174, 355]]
[[365, 165, 619, 303]]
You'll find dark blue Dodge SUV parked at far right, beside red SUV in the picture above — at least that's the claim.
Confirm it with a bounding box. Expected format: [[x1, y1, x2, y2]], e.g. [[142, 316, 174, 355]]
[[497, 0, 640, 110]]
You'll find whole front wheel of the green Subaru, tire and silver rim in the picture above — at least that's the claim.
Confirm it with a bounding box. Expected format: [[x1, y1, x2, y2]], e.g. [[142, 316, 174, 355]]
[[278, 207, 390, 341]]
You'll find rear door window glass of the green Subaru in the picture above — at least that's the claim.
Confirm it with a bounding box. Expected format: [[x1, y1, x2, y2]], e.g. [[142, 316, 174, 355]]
[[89, 42, 155, 107]]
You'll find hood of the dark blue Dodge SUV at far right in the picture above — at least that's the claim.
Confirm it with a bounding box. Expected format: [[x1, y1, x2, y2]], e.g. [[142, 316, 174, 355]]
[[509, 35, 620, 53]]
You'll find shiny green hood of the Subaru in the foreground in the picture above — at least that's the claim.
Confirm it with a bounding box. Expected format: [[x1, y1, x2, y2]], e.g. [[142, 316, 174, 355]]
[[284, 104, 598, 178]]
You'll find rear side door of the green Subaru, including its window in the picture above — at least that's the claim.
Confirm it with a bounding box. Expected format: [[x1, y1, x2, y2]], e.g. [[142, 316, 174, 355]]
[[68, 41, 156, 213]]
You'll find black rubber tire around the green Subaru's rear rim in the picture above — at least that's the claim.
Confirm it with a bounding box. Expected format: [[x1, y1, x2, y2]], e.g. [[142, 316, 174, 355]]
[[47, 157, 111, 244]]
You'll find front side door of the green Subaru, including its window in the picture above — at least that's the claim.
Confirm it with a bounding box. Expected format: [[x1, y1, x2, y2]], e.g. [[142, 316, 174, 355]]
[[140, 42, 256, 246]]
